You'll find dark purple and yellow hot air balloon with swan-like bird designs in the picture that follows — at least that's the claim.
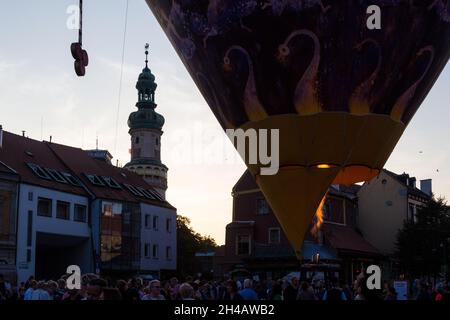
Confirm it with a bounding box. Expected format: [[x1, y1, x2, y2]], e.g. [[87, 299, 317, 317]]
[[147, 0, 450, 257]]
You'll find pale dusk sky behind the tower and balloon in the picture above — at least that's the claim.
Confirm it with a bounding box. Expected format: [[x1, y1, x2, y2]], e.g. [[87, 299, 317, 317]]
[[0, 0, 450, 244]]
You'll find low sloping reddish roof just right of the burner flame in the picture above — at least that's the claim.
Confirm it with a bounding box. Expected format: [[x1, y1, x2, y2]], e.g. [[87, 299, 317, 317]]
[[321, 223, 380, 255]]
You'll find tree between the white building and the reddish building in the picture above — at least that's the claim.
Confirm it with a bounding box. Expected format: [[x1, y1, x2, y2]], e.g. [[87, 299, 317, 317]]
[[177, 215, 217, 277]]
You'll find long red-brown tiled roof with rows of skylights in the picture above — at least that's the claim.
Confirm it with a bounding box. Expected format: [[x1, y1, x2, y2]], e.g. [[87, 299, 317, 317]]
[[0, 132, 175, 209]]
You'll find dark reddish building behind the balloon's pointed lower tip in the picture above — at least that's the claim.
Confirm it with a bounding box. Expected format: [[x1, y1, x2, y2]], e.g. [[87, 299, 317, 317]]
[[220, 171, 380, 281]]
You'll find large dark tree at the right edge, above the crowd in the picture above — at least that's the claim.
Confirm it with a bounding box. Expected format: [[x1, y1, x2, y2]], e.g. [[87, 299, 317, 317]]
[[397, 198, 450, 277]]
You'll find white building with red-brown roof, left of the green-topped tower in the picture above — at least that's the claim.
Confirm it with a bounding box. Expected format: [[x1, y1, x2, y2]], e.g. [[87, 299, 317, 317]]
[[0, 126, 176, 283]]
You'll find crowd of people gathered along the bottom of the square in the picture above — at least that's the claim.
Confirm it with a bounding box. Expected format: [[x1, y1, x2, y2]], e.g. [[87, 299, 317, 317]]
[[0, 274, 450, 301]]
